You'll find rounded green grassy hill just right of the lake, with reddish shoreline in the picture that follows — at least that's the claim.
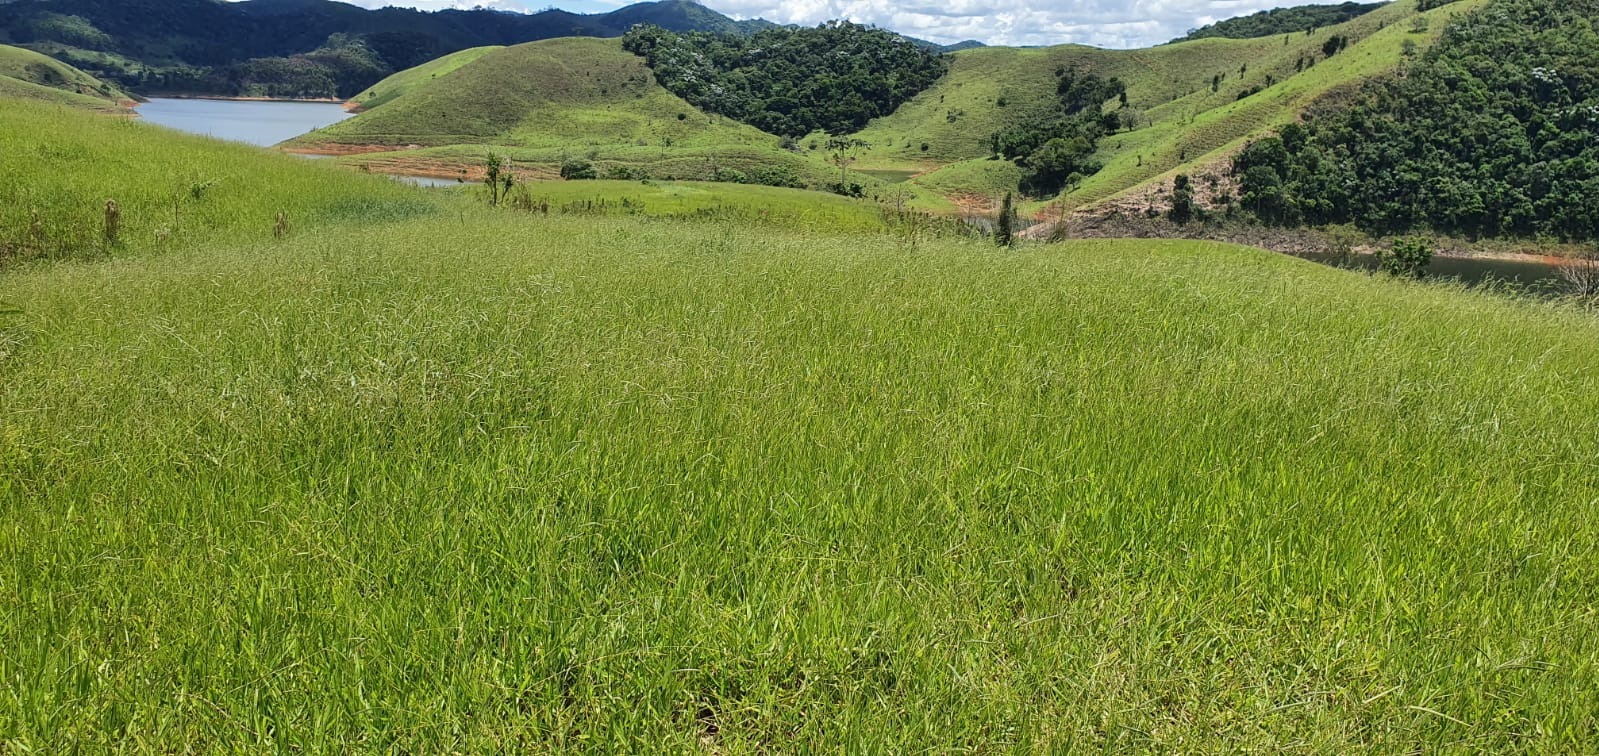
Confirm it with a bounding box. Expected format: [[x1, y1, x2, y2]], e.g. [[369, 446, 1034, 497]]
[[285, 37, 876, 193]]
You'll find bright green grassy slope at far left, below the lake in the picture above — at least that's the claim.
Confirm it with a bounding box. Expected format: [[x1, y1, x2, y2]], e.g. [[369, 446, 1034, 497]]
[[0, 99, 437, 265]]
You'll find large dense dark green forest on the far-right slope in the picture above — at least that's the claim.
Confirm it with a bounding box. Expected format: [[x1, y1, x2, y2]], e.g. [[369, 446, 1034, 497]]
[[1234, 0, 1599, 238]]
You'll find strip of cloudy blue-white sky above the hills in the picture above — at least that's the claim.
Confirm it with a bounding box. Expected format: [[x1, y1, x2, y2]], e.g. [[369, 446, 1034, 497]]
[[246, 0, 1298, 48]]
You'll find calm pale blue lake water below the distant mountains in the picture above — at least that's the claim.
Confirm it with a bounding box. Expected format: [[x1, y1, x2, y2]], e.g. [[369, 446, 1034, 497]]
[[139, 97, 350, 147]]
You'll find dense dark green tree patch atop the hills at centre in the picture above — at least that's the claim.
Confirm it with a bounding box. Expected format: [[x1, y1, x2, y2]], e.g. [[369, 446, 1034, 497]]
[[622, 21, 948, 137]]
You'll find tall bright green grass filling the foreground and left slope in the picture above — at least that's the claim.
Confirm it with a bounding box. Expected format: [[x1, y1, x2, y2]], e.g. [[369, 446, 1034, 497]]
[[0, 88, 1599, 753]]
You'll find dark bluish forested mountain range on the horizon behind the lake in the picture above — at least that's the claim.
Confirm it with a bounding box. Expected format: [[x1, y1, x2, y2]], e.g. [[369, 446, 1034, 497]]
[[0, 0, 772, 97]]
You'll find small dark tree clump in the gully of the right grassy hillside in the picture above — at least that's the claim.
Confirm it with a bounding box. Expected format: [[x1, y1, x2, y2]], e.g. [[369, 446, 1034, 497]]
[[991, 69, 1127, 195]]
